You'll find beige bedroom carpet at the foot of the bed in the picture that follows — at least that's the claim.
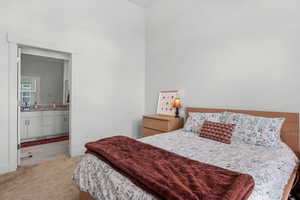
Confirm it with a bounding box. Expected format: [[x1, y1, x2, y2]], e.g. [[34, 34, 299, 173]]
[[0, 157, 80, 200]]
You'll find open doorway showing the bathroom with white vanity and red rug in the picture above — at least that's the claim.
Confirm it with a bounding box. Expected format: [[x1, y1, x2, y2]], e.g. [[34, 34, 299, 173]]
[[18, 46, 71, 166]]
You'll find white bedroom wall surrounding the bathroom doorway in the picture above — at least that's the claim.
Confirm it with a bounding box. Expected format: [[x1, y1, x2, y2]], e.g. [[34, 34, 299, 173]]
[[0, 0, 145, 173]]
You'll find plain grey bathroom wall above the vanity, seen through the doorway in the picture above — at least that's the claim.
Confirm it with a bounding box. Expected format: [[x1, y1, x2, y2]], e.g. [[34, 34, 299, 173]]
[[21, 54, 64, 105]]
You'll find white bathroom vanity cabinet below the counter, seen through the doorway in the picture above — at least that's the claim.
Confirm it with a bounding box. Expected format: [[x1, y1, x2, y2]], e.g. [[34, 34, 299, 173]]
[[20, 111, 69, 141]]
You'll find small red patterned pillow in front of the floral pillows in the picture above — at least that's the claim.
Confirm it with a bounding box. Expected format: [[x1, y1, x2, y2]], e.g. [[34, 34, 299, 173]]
[[200, 121, 235, 144]]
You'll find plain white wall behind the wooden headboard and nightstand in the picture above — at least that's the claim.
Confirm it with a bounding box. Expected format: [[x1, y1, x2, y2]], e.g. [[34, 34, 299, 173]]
[[146, 0, 300, 113]]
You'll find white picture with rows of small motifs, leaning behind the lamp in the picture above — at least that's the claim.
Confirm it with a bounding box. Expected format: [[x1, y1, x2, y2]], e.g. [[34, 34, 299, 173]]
[[157, 90, 178, 116]]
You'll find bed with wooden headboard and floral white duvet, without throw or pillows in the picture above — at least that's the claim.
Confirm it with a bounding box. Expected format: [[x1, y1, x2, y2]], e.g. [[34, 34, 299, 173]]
[[74, 108, 300, 200]]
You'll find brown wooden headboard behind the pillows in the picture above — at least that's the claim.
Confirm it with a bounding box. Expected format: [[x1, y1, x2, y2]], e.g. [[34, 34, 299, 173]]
[[185, 107, 300, 158]]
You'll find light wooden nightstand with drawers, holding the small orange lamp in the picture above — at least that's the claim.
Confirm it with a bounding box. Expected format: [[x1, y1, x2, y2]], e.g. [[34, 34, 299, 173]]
[[143, 115, 183, 137]]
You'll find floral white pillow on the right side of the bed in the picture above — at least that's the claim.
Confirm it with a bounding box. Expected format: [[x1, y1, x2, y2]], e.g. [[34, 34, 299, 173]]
[[224, 112, 284, 147]]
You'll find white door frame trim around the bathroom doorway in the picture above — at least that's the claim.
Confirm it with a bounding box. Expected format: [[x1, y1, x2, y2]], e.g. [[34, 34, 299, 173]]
[[7, 33, 74, 171]]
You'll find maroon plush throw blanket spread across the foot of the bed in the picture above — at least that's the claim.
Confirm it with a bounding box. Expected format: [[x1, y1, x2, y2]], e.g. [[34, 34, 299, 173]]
[[85, 136, 254, 200]]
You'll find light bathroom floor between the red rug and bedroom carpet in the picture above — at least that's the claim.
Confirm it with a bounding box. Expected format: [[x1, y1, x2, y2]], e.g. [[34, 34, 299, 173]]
[[20, 141, 69, 166]]
